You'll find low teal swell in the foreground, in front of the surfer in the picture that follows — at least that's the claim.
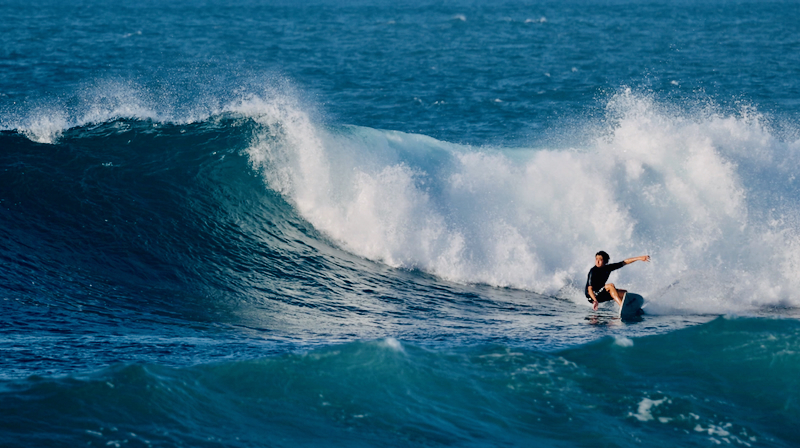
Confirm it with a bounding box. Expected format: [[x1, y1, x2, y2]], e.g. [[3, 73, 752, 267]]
[[0, 318, 800, 447]]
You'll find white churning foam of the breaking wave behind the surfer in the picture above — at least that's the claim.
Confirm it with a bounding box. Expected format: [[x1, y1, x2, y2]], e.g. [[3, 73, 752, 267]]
[[243, 91, 800, 313]]
